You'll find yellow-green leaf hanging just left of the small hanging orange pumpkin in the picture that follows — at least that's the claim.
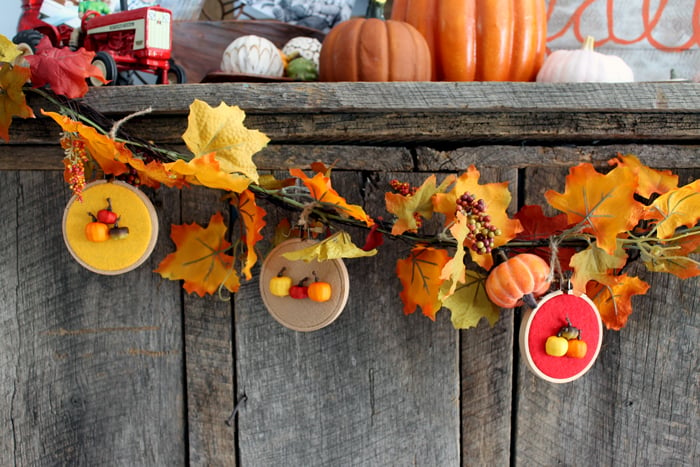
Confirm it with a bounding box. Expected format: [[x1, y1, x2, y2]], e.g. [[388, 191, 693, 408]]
[[442, 270, 500, 329]]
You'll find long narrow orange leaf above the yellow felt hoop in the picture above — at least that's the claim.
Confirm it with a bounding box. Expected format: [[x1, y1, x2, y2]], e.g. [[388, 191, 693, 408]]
[[41, 110, 133, 176]]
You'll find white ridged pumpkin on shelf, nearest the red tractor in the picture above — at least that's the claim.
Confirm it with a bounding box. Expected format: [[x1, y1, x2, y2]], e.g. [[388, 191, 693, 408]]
[[221, 35, 284, 77]]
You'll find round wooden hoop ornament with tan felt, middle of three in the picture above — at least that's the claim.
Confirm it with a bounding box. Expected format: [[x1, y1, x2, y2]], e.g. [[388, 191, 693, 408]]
[[260, 238, 350, 332]]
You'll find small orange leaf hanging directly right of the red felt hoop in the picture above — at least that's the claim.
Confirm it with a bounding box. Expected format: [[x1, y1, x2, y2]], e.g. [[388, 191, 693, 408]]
[[586, 274, 649, 331]]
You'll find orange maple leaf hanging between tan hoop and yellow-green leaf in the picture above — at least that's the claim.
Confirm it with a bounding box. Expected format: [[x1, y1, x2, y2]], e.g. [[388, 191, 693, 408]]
[[396, 245, 449, 320]]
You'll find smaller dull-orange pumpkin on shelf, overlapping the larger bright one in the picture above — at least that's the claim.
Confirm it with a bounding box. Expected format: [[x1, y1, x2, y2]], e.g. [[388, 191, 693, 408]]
[[319, 0, 431, 81]]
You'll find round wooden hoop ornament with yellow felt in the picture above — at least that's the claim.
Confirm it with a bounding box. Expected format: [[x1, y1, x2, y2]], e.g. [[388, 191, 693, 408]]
[[63, 180, 158, 275]]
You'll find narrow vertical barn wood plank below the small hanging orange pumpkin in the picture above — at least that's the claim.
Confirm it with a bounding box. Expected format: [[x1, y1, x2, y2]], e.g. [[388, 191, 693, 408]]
[[460, 165, 518, 465]]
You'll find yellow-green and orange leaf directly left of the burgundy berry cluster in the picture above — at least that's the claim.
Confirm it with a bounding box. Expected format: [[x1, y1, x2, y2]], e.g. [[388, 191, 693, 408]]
[[384, 175, 455, 235]]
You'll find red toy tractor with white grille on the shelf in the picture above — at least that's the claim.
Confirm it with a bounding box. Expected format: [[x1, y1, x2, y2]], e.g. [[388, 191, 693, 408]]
[[13, 0, 186, 85]]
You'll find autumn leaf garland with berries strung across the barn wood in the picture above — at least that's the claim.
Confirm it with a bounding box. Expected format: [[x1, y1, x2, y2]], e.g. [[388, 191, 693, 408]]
[[0, 37, 700, 329]]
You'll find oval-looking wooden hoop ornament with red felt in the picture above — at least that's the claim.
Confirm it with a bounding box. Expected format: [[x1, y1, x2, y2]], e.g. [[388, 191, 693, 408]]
[[520, 291, 603, 383]]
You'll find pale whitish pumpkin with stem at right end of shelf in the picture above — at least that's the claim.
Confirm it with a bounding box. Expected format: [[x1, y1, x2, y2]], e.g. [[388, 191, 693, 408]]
[[537, 36, 634, 83]]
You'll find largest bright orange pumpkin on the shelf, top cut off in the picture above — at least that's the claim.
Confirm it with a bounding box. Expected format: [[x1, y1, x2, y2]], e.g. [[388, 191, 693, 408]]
[[391, 0, 547, 81]]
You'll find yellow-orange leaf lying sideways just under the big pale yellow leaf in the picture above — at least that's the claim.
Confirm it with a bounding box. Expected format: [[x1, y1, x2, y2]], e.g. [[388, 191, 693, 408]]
[[165, 153, 251, 193]]
